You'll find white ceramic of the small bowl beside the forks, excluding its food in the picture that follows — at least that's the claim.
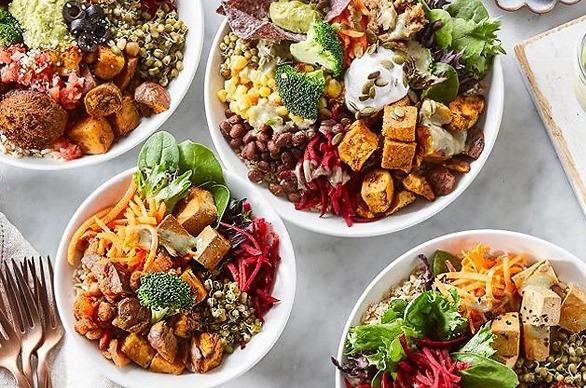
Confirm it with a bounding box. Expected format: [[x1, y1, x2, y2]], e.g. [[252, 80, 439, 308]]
[[55, 169, 296, 388]]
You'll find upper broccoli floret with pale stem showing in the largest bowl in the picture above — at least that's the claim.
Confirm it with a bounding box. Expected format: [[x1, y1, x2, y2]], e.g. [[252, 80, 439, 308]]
[[291, 20, 344, 77]]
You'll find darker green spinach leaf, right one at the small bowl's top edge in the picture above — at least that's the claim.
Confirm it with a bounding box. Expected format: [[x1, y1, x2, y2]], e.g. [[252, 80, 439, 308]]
[[179, 140, 225, 185]]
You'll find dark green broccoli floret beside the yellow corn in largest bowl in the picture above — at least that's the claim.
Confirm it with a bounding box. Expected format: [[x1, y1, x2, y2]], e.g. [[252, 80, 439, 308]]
[[275, 65, 326, 120]]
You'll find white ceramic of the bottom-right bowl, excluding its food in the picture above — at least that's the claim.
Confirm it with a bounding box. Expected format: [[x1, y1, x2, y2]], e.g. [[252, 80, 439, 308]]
[[335, 230, 586, 388]]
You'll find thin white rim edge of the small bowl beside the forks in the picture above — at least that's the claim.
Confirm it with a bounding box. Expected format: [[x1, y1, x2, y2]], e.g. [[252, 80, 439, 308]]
[[53, 167, 297, 387]]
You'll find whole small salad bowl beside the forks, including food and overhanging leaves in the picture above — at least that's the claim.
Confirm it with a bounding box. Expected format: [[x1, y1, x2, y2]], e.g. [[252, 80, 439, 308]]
[[56, 132, 295, 387]]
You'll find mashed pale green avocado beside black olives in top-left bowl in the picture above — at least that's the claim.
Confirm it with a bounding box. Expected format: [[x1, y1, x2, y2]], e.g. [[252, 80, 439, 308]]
[[9, 0, 73, 49]]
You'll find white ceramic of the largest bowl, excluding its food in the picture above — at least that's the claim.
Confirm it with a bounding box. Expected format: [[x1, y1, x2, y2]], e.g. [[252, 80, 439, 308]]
[[204, 21, 504, 237]]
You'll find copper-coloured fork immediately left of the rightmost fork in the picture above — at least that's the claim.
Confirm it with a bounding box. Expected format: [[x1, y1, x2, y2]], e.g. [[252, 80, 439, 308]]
[[4, 259, 43, 385]]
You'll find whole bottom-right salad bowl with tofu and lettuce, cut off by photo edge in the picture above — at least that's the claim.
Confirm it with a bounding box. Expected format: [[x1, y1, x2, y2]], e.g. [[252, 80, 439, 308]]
[[332, 230, 586, 388]]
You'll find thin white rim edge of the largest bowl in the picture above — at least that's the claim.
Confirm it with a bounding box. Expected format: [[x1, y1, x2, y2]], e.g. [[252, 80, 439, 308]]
[[204, 19, 504, 238]]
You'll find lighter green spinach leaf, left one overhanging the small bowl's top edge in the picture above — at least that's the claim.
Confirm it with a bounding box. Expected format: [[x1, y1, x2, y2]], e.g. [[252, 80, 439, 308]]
[[138, 131, 179, 171]]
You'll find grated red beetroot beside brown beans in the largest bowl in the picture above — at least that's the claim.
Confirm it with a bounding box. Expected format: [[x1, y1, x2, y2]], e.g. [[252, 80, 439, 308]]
[[295, 133, 355, 226]]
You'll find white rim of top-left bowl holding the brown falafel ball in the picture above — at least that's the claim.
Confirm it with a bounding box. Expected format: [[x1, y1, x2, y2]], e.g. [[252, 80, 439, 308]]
[[0, 0, 205, 171]]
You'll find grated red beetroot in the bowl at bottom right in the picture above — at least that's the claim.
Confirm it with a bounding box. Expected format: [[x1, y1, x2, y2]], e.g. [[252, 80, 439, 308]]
[[393, 337, 468, 388]]
